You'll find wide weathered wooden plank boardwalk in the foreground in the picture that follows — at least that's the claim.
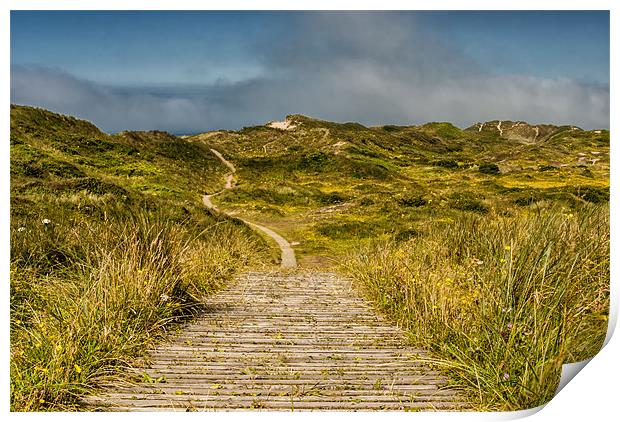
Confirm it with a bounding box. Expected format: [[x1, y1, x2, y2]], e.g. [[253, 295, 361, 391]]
[[87, 272, 463, 411]]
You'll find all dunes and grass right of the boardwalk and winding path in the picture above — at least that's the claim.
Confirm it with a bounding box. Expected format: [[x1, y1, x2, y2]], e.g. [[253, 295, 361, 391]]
[[190, 115, 609, 410]]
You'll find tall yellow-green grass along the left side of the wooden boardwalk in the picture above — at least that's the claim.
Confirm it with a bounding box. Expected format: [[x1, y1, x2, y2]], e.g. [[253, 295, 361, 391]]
[[11, 203, 259, 411]]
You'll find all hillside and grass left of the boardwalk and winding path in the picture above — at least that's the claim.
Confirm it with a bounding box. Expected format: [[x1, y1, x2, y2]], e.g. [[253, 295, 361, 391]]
[[11, 106, 270, 411]]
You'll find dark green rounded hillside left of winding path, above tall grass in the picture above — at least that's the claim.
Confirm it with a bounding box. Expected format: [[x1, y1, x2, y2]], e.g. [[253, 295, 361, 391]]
[[11, 106, 232, 204]]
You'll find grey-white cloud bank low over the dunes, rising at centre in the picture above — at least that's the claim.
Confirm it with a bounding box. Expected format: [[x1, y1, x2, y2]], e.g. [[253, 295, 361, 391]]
[[11, 13, 610, 133]]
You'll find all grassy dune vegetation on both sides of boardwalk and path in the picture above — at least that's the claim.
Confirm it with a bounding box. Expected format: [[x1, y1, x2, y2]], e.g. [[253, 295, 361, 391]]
[[11, 107, 609, 410]]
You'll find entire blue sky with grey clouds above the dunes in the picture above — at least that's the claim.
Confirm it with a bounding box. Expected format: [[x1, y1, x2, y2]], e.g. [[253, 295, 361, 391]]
[[11, 11, 609, 133]]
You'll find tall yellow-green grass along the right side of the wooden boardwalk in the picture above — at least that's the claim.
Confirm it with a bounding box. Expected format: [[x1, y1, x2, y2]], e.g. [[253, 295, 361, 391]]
[[343, 206, 609, 410]]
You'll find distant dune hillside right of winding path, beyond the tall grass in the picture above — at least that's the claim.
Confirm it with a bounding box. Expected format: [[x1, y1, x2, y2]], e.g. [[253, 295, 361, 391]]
[[187, 115, 609, 263]]
